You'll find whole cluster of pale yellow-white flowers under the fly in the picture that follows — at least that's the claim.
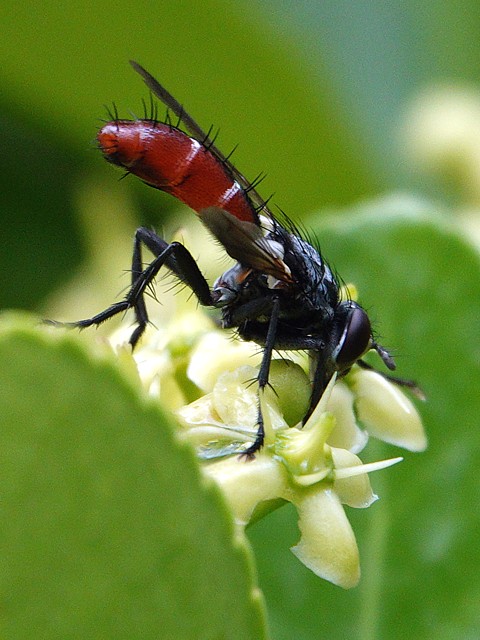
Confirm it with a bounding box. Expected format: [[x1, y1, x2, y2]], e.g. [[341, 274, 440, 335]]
[[112, 284, 426, 588]]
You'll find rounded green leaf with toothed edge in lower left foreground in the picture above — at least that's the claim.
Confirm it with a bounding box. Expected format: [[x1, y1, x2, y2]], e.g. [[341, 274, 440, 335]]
[[0, 317, 266, 640]]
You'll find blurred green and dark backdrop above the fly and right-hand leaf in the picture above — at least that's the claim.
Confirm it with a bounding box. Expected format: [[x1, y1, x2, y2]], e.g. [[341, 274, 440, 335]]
[[0, 0, 478, 308]]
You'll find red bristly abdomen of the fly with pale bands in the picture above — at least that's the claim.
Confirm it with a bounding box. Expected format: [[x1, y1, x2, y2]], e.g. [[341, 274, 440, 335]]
[[97, 120, 257, 223]]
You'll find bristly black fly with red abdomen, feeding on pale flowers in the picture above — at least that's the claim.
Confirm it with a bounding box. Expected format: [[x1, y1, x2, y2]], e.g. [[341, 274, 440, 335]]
[[62, 62, 414, 457]]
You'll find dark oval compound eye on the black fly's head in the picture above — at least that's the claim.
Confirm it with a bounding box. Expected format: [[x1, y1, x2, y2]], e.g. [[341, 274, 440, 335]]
[[335, 303, 372, 371]]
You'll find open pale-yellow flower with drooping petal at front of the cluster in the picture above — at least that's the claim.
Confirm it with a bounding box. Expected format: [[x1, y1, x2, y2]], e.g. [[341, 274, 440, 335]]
[[178, 362, 412, 588]]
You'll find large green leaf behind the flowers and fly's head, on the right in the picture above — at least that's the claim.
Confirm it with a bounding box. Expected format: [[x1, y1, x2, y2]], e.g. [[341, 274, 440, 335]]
[[249, 200, 480, 640]]
